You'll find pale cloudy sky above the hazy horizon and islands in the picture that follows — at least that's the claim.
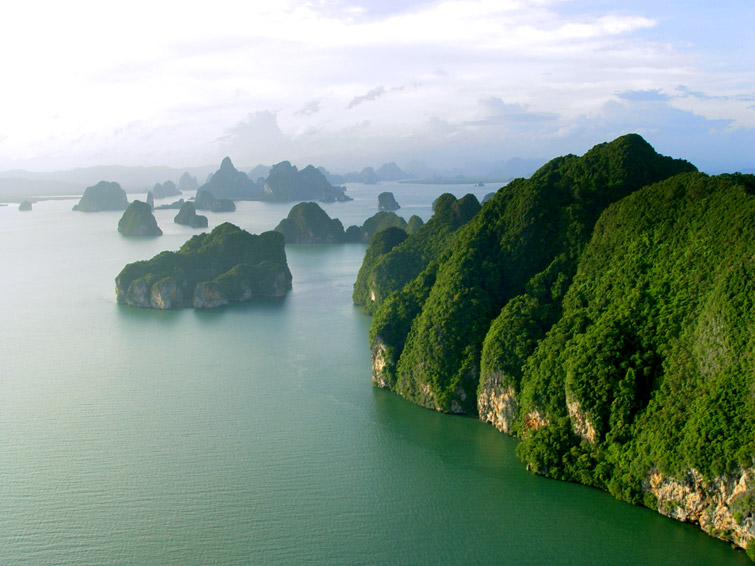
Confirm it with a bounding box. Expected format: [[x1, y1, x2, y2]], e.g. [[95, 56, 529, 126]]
[[0, 0, 755, 173]]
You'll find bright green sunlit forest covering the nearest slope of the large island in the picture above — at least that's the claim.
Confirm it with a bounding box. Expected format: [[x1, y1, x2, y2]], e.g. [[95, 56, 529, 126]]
[[516, 173, 755, 496]]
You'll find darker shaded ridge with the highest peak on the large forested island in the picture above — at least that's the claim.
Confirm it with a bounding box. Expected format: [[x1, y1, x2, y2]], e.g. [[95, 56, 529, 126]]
[[370, 135, 694, 413]]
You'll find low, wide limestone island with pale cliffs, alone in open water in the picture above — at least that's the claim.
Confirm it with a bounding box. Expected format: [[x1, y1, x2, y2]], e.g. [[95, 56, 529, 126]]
[[115, 222, 292, 310]]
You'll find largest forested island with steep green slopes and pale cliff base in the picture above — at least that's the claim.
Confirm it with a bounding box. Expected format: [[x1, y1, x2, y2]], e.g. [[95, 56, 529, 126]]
[[354, 134, 755, 559]]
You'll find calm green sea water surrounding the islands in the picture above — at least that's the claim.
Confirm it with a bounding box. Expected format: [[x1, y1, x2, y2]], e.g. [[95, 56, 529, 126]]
[[0, 183, 750, 566]]
